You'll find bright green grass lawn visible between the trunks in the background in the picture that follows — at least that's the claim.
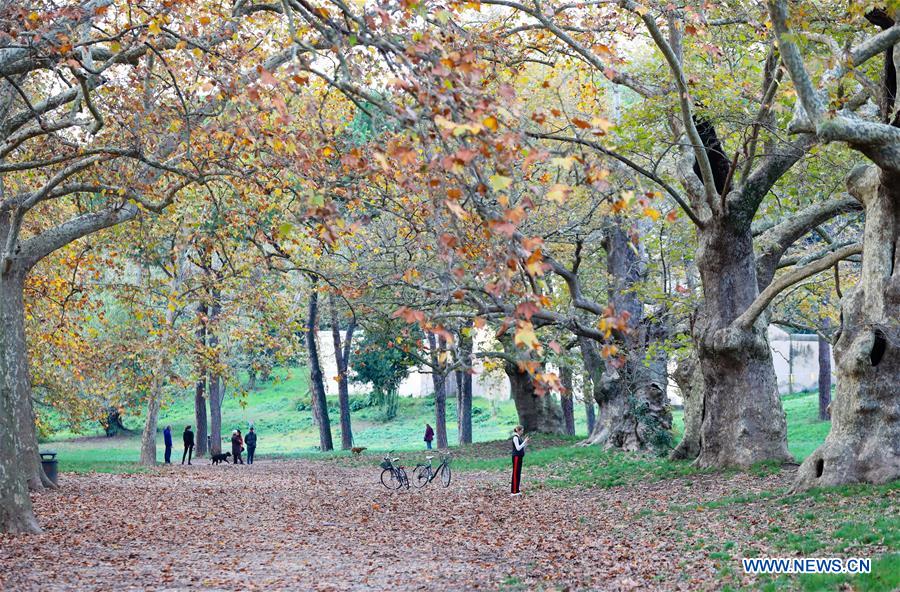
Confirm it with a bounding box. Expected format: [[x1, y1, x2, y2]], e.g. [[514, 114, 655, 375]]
[[42, 369, 830, 476]]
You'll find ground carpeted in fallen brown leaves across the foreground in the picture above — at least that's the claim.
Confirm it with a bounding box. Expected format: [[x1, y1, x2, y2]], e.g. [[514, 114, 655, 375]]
[[0, 459, 900, 591]]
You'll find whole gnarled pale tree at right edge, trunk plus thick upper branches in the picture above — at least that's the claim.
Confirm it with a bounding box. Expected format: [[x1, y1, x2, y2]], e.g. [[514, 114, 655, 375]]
[[768, 0, 900, 489]]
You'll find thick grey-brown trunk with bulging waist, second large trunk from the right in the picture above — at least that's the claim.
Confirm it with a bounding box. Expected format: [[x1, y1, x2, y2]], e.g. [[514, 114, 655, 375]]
[[694, 219, 791, 468]]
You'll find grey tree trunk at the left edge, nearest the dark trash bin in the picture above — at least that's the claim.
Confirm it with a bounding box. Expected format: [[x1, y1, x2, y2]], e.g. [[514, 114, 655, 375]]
[[0, 269, 43, 533]]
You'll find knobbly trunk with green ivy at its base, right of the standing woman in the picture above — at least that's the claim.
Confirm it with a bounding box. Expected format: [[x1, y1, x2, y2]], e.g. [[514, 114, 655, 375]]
[[581, 224, 672, 450]]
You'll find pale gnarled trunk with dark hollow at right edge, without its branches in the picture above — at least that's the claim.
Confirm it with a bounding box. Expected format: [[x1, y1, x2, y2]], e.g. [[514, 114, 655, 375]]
[[794, 167, 900, 489]]
